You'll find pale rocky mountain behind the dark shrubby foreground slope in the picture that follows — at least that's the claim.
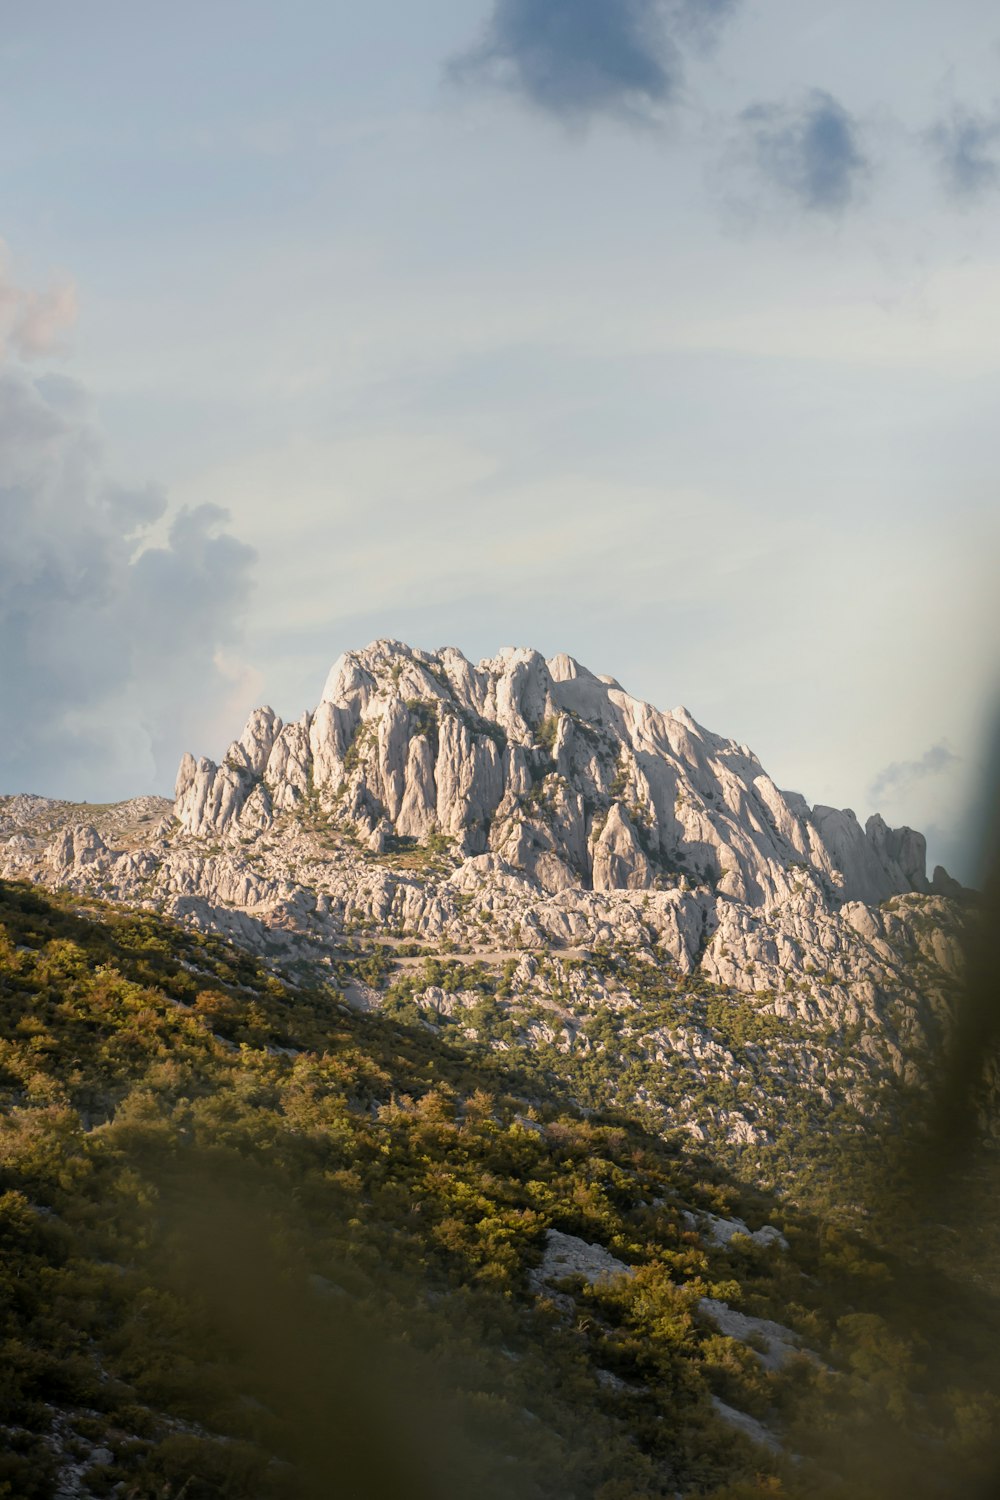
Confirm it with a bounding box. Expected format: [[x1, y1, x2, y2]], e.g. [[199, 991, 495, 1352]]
[[0, 641, 967, 1181]]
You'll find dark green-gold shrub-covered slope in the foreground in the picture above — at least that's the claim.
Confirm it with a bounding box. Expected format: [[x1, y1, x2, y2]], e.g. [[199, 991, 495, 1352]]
[[0, 885, 1000, 1500]]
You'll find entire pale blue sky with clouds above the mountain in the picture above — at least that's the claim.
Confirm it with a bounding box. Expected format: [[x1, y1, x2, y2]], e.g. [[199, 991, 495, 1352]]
[[0, 0, 1000, 879]]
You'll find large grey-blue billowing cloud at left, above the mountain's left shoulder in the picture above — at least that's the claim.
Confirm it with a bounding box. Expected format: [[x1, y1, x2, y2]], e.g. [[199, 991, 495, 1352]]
[[0, 259, 253, 800]]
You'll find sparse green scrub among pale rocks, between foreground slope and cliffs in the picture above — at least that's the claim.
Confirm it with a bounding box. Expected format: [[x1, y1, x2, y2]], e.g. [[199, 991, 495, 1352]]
[[379, 942, 925, 1224]]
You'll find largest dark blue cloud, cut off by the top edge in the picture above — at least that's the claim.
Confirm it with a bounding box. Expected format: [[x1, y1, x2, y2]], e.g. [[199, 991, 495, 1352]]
[[448, 0, 736, 120]]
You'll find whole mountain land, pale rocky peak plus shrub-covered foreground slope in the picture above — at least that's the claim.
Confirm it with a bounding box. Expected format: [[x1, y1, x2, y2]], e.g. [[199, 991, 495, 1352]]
[[0, 641, 1000, 1500]]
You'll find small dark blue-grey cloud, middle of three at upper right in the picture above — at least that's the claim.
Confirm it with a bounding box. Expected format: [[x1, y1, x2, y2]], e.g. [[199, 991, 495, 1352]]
[[741, 89, 868, 213]]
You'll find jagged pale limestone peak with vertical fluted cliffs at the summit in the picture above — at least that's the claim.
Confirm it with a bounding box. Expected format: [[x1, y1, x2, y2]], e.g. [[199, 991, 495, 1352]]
[[174, 641, 948, 906]]
